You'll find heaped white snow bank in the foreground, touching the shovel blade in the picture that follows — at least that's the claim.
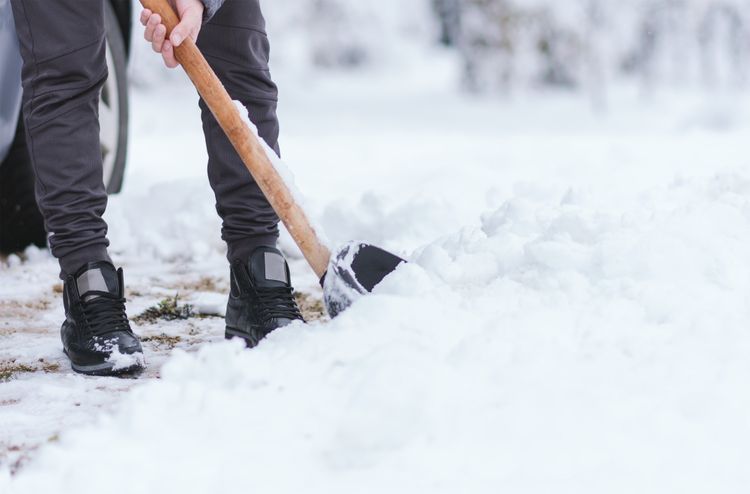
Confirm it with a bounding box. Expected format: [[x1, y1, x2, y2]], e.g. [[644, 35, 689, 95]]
[[0, 174, 750, 494]]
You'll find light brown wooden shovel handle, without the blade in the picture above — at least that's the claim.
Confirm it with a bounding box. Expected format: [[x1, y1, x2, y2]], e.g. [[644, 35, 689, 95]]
[[140, 0, 331, 278]]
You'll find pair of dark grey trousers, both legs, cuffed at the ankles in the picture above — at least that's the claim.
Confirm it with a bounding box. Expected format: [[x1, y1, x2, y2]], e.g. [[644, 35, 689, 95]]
[[11, 0, 279, 273]]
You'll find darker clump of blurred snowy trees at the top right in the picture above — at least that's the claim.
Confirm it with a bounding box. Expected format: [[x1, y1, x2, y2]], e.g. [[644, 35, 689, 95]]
[[433, 0, 750, 91]]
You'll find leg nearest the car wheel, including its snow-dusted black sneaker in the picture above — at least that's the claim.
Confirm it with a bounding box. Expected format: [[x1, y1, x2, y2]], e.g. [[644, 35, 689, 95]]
[[11, 0, 144, 375]]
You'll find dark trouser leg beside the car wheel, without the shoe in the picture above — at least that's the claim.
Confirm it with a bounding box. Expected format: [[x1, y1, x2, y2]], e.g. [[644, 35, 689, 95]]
[[11, 0, 109, 275]]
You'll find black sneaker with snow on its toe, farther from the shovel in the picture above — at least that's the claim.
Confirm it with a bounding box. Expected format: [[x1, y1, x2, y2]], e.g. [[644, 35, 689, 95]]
[[60, 261, 145, 376]]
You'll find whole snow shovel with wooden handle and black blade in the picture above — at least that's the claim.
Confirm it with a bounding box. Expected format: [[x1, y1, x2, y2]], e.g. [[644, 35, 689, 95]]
[[140, 0, 405, 317]]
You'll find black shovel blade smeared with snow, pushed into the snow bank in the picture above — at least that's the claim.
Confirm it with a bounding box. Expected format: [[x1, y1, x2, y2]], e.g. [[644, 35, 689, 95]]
[[321, 242, 406, 317]]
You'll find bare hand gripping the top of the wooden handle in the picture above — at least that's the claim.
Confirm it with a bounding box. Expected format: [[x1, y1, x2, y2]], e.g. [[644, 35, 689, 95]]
[[141, 0, 203, 69]]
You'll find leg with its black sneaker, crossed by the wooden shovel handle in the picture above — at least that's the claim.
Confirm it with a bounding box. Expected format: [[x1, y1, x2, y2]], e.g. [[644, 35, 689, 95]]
[[198, 0, 302, 346]]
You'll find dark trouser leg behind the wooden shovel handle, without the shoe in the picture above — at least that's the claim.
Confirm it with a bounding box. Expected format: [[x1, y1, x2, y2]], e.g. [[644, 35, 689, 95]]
[[198, 0, 279, 262]]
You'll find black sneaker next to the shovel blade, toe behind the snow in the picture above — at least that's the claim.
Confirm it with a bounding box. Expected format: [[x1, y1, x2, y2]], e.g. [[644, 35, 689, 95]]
[[225, 247, 304, 347]]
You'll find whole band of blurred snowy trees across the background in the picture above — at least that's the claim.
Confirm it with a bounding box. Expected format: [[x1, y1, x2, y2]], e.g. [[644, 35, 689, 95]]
[[134, 0, 750, 95]]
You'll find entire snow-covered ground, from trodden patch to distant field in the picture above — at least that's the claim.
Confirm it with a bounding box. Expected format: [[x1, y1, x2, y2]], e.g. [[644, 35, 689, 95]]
[[0, 29, 750, 494]]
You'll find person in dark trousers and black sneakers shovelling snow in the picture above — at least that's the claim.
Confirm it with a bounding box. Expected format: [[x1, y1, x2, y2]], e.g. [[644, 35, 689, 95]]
[[11, 0, 302, 375]]
